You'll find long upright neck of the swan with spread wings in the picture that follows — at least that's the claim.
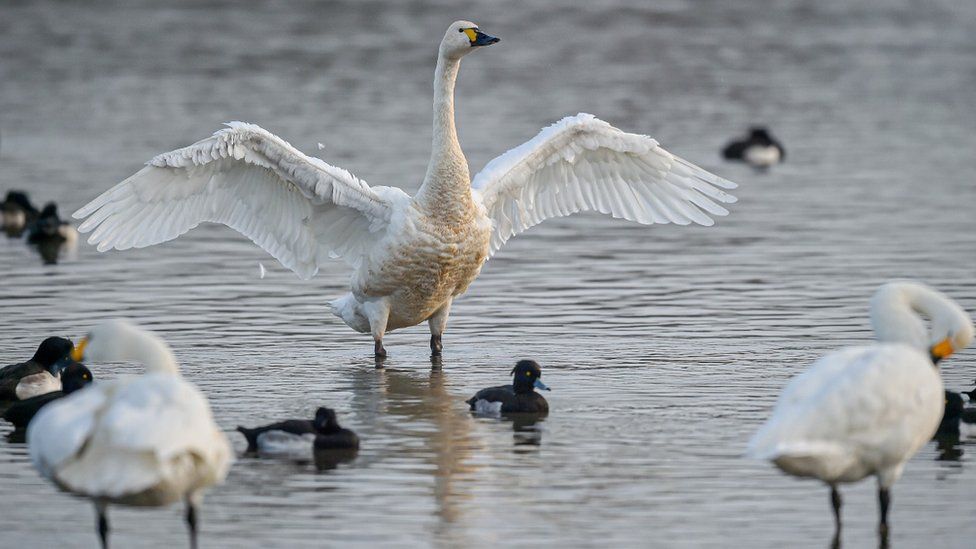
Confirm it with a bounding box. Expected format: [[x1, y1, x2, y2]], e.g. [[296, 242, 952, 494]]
[[417, 53, 471, 221]]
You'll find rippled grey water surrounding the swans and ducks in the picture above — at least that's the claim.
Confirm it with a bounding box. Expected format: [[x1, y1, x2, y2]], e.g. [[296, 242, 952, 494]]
[[0, 0, 976, 548]]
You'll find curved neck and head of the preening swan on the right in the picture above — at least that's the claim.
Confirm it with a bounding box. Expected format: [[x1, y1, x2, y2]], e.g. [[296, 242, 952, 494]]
[[871, 281, 974, 363]]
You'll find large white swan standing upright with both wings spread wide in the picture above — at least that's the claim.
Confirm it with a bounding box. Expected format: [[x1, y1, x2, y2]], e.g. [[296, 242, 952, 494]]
[[74, 21, 735, 356]]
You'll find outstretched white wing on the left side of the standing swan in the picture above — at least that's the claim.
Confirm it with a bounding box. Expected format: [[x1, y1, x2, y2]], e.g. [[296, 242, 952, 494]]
[[74, 122, 405, 278]]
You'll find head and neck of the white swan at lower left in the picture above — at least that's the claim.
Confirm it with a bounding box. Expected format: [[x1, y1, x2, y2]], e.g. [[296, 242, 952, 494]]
[[71, 320, 178, 373]]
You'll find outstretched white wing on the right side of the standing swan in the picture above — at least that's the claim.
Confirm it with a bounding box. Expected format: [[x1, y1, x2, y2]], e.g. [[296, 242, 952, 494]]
[[472, 113, 736, 254]]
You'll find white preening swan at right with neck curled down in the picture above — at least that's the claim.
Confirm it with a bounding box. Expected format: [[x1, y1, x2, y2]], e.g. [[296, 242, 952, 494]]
[[749, 282, 973, 534]]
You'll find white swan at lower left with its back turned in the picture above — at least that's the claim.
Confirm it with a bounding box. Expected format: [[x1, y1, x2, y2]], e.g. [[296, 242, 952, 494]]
[[27, 321, 233, 547]]
